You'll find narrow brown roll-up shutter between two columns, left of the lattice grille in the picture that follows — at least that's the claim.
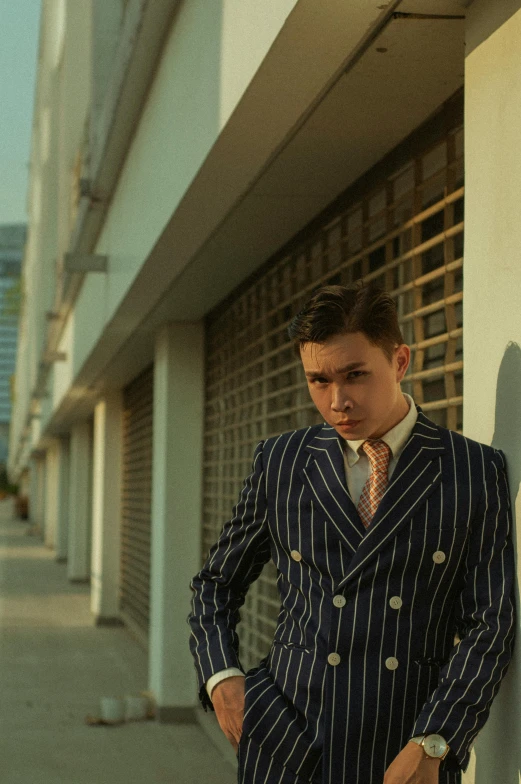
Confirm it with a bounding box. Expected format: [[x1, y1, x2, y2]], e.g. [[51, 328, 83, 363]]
[[120, 365, 154, 644]]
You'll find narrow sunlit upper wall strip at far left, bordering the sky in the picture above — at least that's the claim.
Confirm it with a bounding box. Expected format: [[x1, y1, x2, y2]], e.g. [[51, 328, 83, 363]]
[[10, 0, 91, 465]]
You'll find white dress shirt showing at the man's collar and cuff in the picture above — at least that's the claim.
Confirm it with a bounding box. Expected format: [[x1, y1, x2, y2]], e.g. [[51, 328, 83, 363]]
[[206, 393, 418, 699]]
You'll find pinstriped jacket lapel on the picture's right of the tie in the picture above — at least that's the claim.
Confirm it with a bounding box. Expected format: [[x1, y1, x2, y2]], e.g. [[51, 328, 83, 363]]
[[338, 409, 445, 588]]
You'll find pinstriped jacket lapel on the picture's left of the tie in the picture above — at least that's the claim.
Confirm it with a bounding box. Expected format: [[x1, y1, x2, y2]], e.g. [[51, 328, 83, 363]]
[[301, 425, 365, 554]]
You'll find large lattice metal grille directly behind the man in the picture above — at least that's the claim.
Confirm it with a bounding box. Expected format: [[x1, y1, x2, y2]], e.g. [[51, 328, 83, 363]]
[[203, 127, 463, 667]]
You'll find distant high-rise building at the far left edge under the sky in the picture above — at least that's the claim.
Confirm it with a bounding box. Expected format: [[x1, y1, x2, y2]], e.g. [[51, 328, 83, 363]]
[[0, 224, 27, 464]]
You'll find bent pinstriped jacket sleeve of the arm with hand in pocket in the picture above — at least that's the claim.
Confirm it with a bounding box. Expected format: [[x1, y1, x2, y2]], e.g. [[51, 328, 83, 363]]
[[188, 442, 270, 709]]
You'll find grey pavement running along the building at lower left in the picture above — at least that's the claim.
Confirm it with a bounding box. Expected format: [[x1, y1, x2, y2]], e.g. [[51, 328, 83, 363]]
[[0, 500, 236, 784]]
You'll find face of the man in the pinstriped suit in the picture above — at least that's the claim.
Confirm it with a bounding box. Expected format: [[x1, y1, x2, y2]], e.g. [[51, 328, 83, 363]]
[[300, 332, 410, 441]]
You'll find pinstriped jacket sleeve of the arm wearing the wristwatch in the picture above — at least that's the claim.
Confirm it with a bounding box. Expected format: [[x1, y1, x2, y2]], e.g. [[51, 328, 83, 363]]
[[413, 450, 515, 769]]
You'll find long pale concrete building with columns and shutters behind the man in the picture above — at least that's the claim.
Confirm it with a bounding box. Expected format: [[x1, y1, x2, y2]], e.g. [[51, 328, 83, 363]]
[[9, 0, 521, 784]]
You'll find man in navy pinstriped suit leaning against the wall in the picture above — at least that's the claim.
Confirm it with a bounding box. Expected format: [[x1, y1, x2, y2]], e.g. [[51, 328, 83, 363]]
[[186, 286, 514, 784]]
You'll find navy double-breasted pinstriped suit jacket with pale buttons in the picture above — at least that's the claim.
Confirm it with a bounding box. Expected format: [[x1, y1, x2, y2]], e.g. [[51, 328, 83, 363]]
[[189, 409, 514, 784]]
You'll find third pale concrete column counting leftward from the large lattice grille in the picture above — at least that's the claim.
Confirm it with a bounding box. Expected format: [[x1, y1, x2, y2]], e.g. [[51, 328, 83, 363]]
[[67, 422, 92, 582]]
